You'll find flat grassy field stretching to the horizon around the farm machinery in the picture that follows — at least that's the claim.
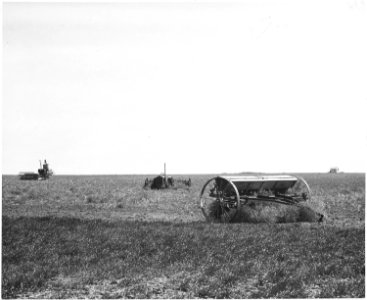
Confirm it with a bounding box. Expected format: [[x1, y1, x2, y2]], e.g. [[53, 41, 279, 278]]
[[2, 174, 365, 298]]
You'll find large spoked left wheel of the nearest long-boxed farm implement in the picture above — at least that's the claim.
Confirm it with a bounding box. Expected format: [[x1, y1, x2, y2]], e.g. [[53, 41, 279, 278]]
[[200, 177, 240, 223]]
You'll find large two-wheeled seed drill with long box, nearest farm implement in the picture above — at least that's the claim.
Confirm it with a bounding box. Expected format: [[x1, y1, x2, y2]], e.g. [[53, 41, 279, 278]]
[[200, 175, 323, 223]]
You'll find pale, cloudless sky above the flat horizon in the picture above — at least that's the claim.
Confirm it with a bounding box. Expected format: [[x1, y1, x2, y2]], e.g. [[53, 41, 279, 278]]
[[2, 0, 367, 174]]
